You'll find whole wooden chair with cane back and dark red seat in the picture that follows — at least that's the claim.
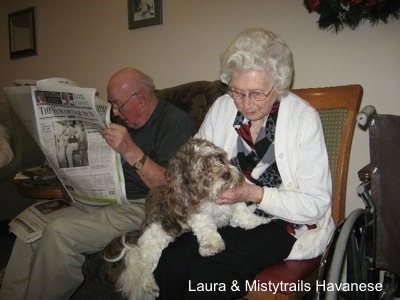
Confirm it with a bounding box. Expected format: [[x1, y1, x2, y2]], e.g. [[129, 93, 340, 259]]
[[245, 85, 363, 300]]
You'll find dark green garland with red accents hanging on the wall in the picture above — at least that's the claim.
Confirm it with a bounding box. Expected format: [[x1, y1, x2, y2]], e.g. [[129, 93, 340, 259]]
[[304, 0, 400, 33]]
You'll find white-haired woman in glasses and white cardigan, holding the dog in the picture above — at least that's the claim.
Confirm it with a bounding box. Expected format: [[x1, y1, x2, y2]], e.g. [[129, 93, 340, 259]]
[[154, 29, 333, 300]]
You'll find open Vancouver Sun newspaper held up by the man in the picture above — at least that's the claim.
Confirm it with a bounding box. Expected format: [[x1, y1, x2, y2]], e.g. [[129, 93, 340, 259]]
[[4, 78, 127, 206]]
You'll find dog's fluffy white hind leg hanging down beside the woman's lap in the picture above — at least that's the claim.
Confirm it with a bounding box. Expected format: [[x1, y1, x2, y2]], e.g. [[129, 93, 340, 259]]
[[117, 223, 174, 300]]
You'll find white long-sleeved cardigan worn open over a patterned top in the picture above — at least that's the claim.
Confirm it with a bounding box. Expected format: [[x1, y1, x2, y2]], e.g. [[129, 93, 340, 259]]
[[196, 93, 334, 259]]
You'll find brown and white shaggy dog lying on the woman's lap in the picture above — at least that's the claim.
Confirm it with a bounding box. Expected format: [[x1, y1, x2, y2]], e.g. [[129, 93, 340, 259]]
[[117, 139, 270, 300]]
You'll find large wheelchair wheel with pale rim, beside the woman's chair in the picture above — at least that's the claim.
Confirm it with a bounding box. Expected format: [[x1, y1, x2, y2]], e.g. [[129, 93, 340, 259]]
[[316, 209, 378, 300]]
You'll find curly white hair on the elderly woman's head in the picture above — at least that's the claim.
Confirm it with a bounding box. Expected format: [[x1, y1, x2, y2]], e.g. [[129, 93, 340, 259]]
[[220, 28, 294, 93]]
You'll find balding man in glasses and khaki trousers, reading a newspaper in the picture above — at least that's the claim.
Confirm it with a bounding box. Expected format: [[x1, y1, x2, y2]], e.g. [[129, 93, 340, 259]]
[[0, 68, 196, 300]]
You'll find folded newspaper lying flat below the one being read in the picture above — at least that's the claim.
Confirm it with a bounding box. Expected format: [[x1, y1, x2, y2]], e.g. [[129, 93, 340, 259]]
[[9, 199, 79, 243]]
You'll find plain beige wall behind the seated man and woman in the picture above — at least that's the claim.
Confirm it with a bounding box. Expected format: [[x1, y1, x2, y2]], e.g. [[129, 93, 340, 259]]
[[0, 0, 400, 216]]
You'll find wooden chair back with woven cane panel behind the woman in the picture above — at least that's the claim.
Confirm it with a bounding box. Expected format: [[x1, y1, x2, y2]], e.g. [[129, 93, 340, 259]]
[[293, 85, 363, 223]]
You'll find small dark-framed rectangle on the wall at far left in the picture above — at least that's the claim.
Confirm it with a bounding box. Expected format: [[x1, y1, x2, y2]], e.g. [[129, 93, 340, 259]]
[[8, 7, 37, 59]]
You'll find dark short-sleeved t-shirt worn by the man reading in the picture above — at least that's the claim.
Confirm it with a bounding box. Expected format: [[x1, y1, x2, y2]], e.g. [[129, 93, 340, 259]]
[[122, 100, 197, 200]]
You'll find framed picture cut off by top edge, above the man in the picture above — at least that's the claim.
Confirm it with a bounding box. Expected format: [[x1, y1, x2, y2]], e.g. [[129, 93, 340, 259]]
[[128, 0, 162, 29]]
